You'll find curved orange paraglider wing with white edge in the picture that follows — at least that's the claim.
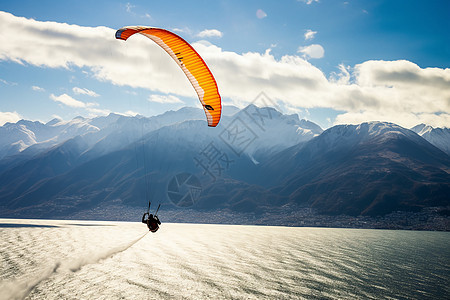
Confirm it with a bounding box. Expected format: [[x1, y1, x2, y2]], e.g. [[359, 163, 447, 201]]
[[116, 26, 222, 127]]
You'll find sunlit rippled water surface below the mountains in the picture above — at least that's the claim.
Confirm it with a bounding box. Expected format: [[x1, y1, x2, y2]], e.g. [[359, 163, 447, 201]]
[[0, 219, 450, 299]]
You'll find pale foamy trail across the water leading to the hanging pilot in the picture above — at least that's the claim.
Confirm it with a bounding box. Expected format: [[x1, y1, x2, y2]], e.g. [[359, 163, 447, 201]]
[[0, 232, 148, 300]]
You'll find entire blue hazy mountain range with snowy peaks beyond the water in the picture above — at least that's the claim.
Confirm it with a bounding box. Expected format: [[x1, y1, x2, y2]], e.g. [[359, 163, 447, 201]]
[[0, 105, 450, 227]]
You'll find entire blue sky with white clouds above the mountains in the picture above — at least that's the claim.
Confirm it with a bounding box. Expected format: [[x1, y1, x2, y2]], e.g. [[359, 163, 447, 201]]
[[0, 0, 450, 128]]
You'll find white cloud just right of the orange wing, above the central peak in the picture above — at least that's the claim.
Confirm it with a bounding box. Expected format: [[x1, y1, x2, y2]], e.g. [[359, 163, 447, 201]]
[[194, 43, 328, 106]]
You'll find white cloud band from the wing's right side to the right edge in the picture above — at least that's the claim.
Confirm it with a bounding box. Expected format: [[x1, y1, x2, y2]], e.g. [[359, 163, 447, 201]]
[[195, 44, 450, 127]]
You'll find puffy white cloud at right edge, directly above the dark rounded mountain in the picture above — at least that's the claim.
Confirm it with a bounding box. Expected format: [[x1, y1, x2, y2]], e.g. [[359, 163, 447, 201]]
[[337, 60, 450, 127]]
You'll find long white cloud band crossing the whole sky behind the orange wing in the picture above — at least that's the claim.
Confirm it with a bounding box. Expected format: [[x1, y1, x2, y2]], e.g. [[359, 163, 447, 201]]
[[0, 12, 450, 127]]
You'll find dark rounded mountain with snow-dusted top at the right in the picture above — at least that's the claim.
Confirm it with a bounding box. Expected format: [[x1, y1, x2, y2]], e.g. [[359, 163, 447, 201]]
[[256, 122, 450, 215]]
